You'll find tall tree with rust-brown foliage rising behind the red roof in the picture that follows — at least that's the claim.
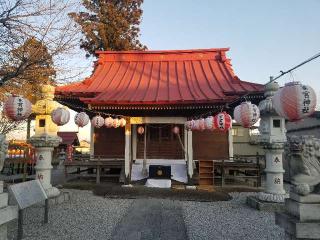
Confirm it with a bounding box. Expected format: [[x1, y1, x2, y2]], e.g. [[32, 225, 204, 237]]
[[70, 0, 146, 56]]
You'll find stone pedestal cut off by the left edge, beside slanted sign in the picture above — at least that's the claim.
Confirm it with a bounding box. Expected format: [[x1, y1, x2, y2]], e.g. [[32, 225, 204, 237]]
[[0, 181, 18, 240]]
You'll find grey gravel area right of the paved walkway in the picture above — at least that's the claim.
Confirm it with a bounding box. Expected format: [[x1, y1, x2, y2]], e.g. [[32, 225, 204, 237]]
[[182, 193, 284, 240]]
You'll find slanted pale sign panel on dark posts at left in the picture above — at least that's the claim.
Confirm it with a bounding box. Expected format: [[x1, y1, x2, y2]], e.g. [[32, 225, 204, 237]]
[[9, 180, 48, 209]]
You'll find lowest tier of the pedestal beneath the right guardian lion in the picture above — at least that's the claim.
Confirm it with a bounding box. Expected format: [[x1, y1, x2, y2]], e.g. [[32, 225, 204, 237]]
[[275, 213, 320, 240]]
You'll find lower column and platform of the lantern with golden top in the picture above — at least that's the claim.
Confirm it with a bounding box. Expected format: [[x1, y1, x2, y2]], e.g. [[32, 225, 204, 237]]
[[29, 134, 61, 198]]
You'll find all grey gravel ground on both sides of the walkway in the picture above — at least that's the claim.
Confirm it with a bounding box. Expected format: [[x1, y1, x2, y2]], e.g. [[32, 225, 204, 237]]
[[9, 190, 284, 240]]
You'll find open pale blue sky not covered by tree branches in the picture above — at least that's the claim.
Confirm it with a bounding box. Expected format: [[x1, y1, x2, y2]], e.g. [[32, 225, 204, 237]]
[[9, 0, 320, 139]]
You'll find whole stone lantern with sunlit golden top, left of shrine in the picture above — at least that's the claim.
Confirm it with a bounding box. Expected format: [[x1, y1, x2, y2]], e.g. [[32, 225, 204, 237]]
[[28, 85, 61, 197]]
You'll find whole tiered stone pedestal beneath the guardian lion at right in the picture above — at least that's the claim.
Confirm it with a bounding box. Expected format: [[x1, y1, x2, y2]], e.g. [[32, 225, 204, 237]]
[[275, 193, 320, 240]]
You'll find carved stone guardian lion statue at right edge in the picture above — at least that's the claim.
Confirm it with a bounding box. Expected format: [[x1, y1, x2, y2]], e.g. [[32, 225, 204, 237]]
[[287, 136, 320, 195]]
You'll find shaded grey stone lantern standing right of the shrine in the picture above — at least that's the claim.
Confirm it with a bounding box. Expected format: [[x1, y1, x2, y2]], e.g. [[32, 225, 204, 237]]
[[258, 79, 288, 202]]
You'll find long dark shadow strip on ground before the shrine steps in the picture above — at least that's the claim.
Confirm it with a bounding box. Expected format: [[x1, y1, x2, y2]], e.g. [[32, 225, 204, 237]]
[[93, 184, 232, 202]]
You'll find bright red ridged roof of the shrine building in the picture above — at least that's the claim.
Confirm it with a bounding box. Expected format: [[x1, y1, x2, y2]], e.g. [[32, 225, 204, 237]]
[[56, 48, 263, 105]]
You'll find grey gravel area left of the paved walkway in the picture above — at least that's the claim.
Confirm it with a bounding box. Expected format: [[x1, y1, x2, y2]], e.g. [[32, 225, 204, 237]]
[[9, 190, 132, 240]]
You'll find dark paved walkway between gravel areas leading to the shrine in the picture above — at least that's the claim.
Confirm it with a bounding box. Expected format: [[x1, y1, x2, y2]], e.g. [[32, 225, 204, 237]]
[[111, 199, 188, 240]]
